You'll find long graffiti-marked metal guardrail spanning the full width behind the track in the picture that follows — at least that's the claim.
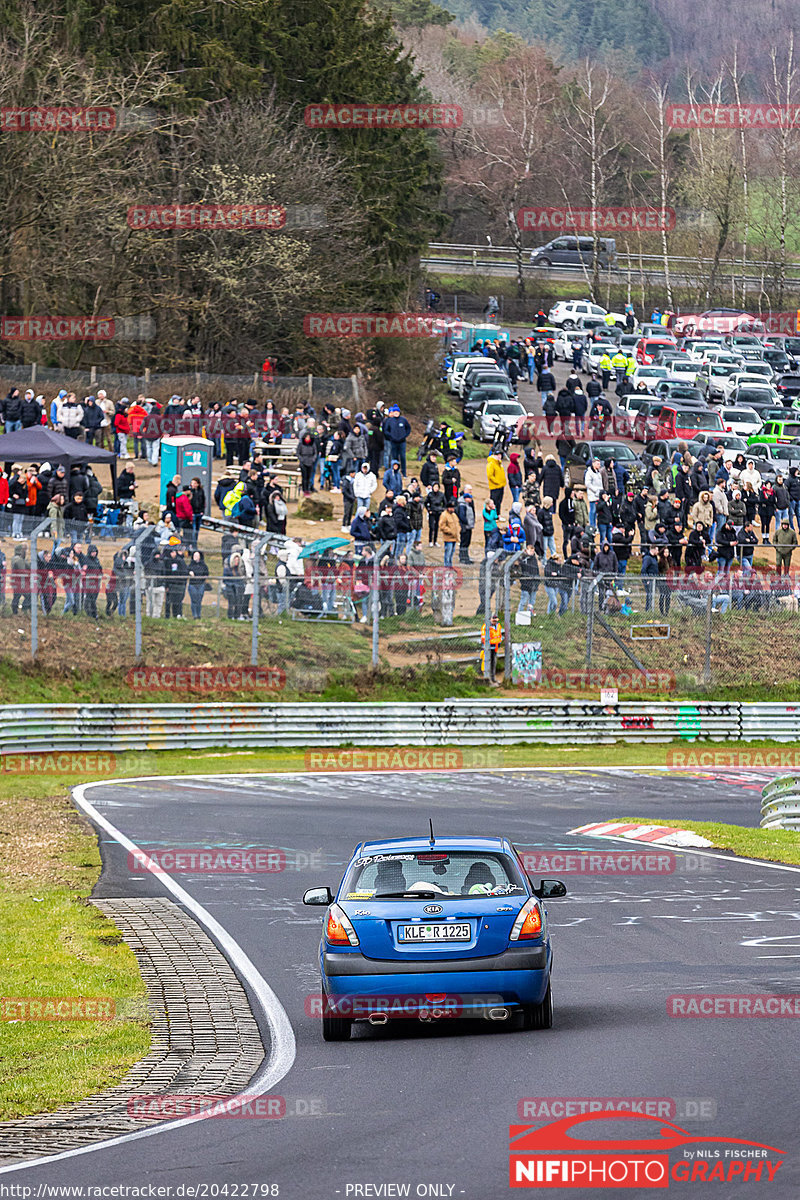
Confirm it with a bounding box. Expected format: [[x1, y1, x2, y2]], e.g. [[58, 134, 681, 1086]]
[[0, 700, 800, 755]]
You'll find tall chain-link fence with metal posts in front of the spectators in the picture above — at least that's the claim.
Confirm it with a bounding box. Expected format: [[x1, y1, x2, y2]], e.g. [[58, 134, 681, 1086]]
[[0, 518, 800, 696]]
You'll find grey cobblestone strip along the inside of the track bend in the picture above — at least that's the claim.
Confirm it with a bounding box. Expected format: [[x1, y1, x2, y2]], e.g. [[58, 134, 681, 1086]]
[[0, 898, 265, 1165]]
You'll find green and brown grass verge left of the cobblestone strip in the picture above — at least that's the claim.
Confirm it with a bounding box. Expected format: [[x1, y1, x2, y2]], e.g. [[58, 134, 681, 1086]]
[[0, 775, 150, 1120]]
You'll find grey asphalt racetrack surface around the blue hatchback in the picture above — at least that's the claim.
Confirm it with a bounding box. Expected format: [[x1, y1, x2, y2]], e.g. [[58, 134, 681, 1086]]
[[10, 769, 800, 1200]]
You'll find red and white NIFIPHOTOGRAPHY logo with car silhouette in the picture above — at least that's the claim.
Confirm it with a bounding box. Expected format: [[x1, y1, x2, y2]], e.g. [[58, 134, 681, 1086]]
[[509, 1109, 783, 1188]]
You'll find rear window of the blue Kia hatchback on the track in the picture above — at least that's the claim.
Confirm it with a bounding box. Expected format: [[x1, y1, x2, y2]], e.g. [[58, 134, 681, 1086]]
[[342, 847, 525, 900]]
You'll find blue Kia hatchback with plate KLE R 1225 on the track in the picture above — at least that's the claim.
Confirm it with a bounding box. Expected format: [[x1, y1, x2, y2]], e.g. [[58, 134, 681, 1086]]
[[303, 833, 566, 1042]]
